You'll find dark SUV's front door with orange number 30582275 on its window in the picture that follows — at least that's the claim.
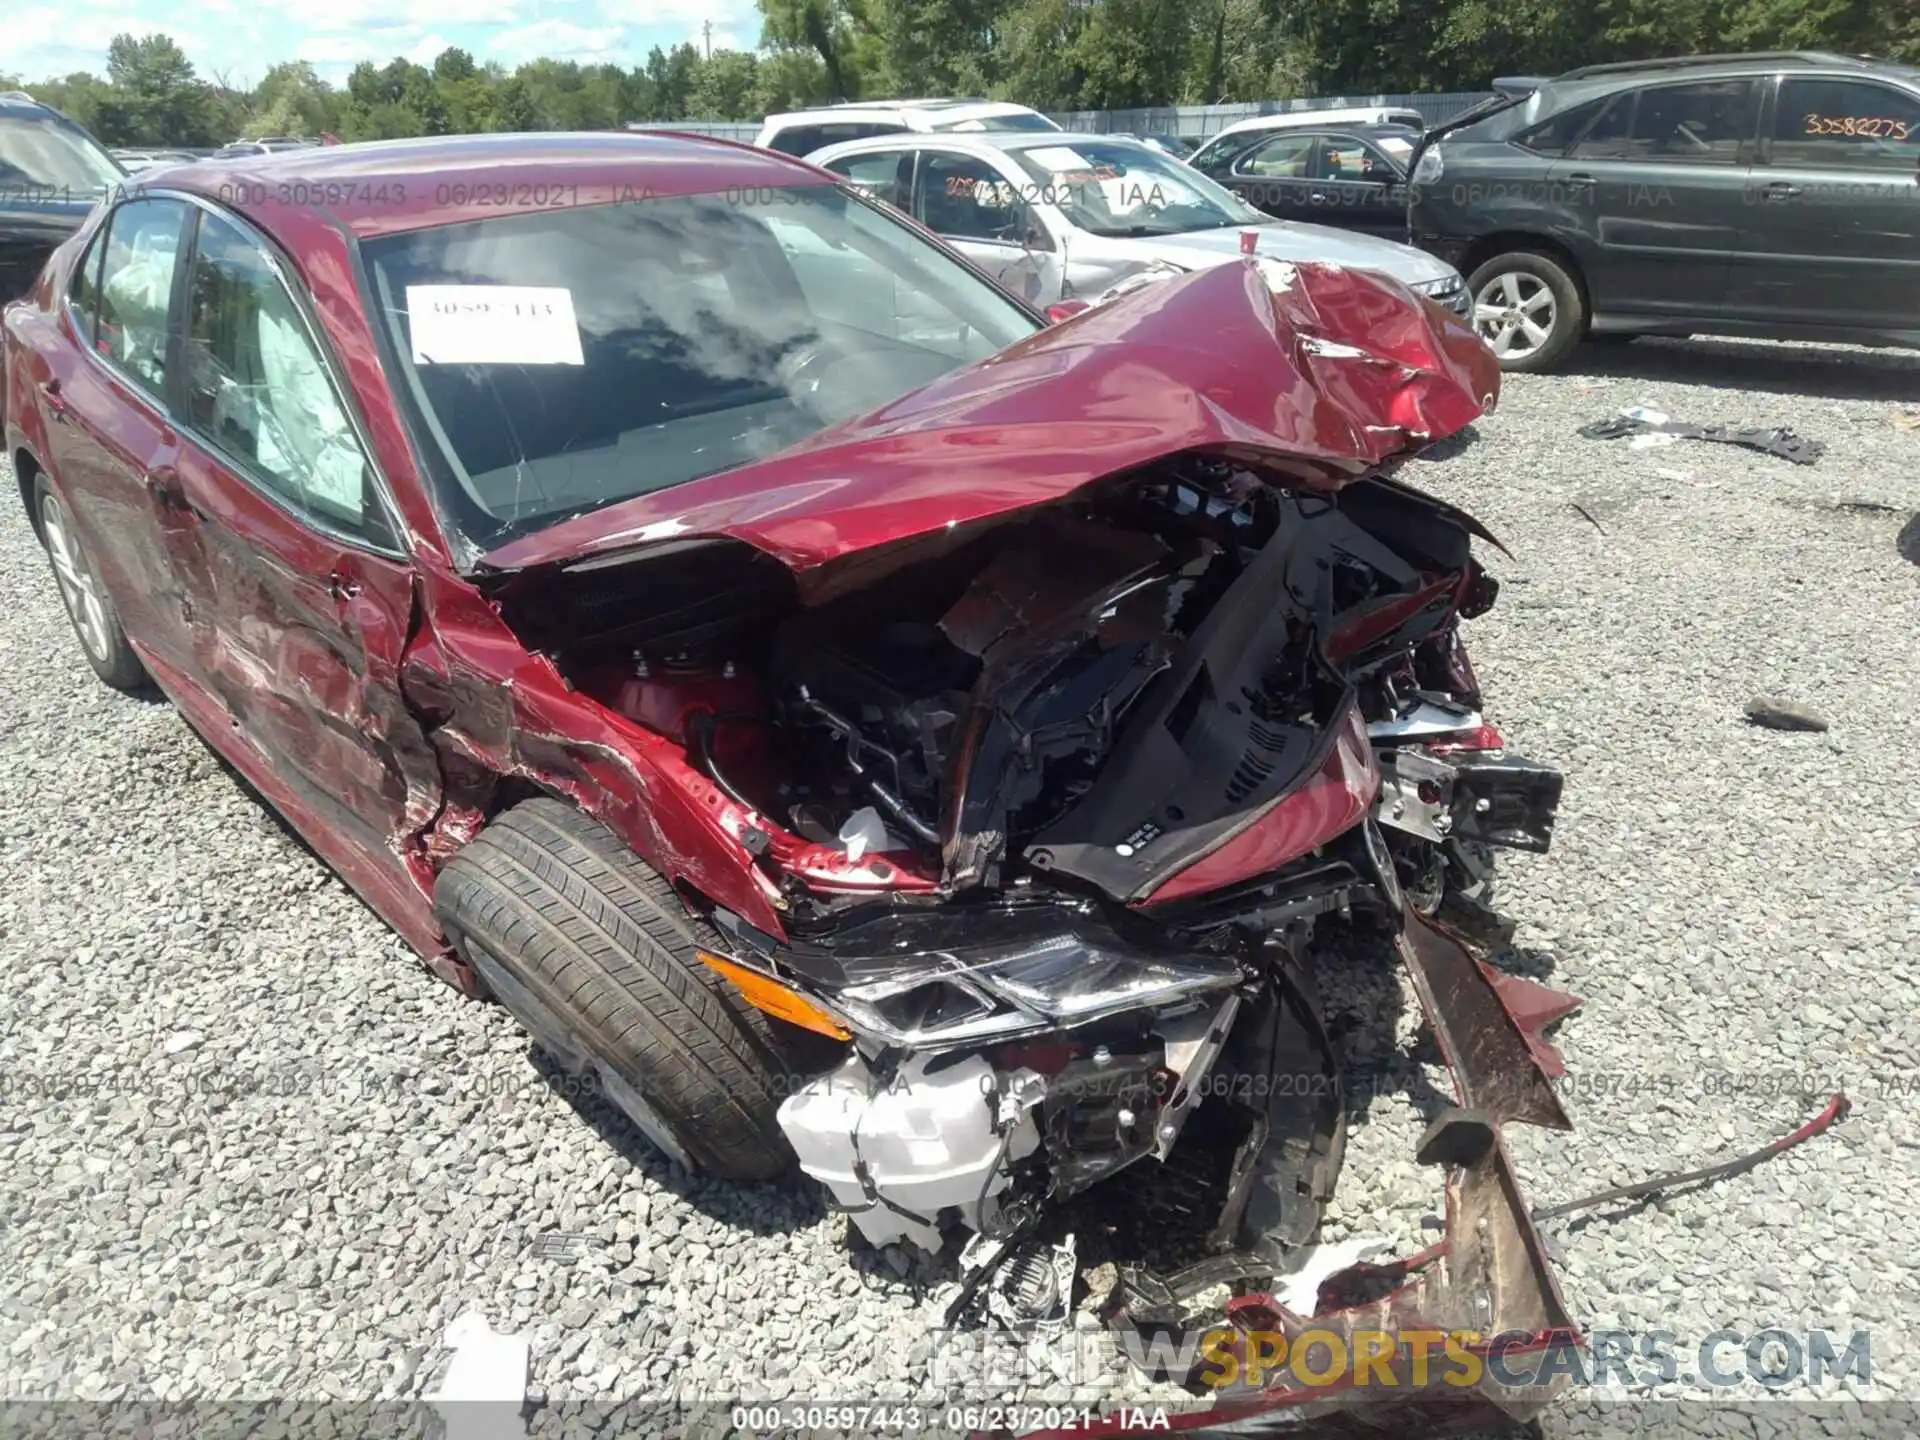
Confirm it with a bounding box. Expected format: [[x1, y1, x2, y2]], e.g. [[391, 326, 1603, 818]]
[[1728, 75, 1920, 330]]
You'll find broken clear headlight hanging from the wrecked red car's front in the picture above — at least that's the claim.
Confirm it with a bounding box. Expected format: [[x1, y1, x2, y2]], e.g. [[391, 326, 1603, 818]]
[[833, 933, 1240, 1050]]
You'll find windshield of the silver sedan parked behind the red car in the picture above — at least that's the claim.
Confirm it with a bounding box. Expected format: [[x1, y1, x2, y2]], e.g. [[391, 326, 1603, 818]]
[[1010, 134, 1267, 236]]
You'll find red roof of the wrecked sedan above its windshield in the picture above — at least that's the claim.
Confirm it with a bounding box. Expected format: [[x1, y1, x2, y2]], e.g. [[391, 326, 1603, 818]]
[[140, 131, 835, 240]]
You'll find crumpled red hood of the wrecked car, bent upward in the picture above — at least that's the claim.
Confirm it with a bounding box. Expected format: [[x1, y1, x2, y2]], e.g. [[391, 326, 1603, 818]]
[[480, 259, 1500, 570]]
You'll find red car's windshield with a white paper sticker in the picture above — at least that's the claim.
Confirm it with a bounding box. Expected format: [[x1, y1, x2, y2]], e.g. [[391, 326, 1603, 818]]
[[363, 184, 1041, 549]]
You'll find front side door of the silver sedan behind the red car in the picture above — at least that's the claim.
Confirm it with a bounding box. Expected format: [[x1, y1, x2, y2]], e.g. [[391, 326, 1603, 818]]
[[912, 150, 1062, 305]]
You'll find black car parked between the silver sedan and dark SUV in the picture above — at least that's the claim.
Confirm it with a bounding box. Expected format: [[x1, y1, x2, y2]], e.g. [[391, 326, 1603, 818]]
[[1192, 125, 1421, 240]]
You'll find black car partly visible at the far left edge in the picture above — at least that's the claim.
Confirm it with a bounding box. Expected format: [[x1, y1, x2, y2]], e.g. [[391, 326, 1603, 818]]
[[0, 90, 125, 303]]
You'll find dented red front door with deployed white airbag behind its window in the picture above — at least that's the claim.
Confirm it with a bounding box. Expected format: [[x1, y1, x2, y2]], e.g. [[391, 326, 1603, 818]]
[[171, 209, 440, 866]]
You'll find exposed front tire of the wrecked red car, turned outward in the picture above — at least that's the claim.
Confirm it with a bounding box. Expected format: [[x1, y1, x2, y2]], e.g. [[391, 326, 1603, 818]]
[[434, 799, 793, 1181]]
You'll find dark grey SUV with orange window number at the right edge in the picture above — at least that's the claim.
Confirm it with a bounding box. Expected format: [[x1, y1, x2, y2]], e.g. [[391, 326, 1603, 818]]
[[1409, 52, 1920, 371]]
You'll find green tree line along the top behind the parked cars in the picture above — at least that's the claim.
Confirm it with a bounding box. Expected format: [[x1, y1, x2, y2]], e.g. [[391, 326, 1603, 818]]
[[0, 0, 1920, 146]]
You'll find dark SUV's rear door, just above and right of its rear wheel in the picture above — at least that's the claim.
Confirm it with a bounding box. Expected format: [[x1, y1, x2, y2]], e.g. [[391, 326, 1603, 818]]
[[1548, 79, 1761, 315]]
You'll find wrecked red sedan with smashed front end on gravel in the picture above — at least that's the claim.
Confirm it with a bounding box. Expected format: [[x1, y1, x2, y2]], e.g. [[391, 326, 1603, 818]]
[[4, 136, 1565, 1436]]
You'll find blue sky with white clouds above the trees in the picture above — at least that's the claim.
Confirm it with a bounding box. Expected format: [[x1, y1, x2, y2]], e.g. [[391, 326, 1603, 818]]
[[18, 0, 760, 86]]
